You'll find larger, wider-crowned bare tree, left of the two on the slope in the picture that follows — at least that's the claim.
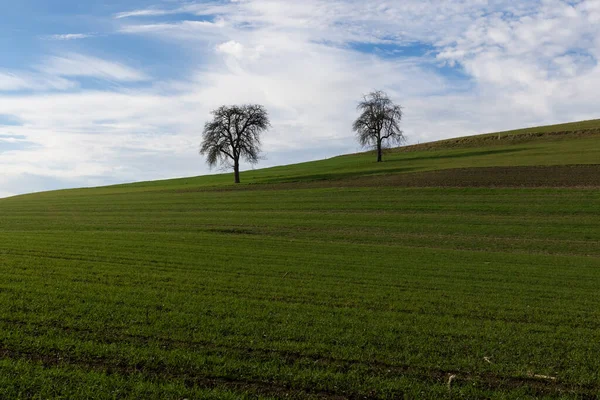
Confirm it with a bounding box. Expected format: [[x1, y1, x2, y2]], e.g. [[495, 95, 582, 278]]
[[200, 104, 271, 183]]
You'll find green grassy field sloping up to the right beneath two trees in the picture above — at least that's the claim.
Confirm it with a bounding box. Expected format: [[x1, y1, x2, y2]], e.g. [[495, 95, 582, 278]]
[[0, 121, 600, 399]]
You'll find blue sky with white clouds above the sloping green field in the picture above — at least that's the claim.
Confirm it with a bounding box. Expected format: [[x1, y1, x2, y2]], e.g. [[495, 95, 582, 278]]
[[0, 0, 600, 197]]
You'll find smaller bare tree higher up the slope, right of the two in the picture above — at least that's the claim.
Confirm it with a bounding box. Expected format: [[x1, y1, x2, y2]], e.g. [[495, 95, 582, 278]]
[[352, 90, 405, 162]]
